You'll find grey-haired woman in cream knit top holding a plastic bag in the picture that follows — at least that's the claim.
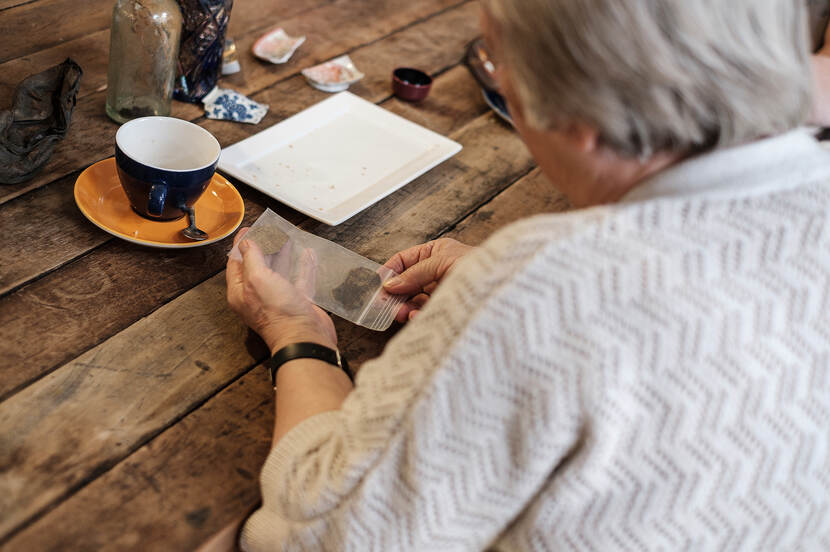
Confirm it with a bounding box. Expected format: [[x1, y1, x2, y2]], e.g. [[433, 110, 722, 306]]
[[227, 0, 830, 551]]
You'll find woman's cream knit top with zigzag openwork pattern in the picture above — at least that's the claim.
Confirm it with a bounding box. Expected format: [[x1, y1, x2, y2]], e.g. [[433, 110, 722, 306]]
[[237, 131, 830, 551]]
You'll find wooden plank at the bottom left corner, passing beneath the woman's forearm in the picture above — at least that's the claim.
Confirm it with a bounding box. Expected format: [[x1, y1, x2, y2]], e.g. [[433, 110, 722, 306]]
[[0, 165, 567, 550]]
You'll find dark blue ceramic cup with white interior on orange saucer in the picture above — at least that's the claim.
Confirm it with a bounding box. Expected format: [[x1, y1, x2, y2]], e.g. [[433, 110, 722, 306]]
[[115, 117, 222, 220]]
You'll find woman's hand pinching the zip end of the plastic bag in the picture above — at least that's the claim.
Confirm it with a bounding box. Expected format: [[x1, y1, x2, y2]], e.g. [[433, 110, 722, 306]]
[[383, 238, 475, 322]]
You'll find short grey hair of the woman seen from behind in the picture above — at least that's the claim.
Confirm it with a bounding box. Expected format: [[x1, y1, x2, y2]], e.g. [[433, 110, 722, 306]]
[[484, 0, 812, 157]]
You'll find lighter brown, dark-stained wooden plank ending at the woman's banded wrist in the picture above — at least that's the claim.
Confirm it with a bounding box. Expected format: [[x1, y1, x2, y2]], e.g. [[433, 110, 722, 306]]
[[0, 274, 253, 535]]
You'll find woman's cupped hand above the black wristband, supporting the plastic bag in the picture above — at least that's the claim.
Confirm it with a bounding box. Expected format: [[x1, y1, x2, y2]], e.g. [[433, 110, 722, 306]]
[[225, 228, 337, 354]]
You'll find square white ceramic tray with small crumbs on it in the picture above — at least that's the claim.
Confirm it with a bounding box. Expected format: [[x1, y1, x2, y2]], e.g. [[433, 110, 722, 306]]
[[219, 92, 461, 226]]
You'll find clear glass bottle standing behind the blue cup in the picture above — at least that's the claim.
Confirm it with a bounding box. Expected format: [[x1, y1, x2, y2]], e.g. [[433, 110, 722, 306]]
[[107, 0, 182, 123]]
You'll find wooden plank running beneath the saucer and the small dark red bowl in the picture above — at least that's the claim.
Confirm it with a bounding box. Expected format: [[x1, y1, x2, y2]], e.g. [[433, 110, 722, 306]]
[[0, 4, 486, 298]]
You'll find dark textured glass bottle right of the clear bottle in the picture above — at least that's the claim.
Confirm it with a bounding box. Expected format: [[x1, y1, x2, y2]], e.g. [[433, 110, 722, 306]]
[[174, 0, 233, 103]]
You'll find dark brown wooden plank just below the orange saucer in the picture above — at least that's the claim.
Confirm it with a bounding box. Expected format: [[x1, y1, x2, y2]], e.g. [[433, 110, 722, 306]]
[[0, 201, 263, 397]]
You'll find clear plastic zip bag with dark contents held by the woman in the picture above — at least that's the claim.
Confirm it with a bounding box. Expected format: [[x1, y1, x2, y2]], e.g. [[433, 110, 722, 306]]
[[229, 209, 407, 331]]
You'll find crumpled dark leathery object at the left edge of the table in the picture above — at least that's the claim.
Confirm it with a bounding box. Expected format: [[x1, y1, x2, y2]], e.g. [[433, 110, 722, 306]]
[[0, 58, 83, 184]]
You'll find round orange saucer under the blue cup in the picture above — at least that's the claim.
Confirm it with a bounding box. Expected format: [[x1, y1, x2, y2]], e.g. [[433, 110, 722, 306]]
[[75, 157, 245, 249]]
